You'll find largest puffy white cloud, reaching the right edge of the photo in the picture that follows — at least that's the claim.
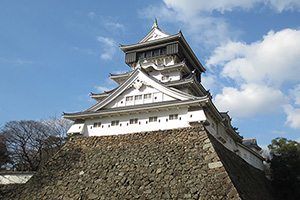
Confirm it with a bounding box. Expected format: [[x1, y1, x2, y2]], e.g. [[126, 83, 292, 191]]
[[207, 29, 300, 87]]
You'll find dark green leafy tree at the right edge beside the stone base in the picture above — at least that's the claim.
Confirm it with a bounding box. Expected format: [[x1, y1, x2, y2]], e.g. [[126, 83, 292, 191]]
[[268, 138, 300, 199]]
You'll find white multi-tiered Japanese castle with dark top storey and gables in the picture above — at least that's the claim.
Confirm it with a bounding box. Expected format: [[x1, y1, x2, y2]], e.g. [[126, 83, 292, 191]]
[[63, 20, 263, 170]]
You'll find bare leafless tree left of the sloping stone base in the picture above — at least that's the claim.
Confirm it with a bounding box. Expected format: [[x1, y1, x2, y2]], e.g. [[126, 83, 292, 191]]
[[1, 118, 70, 171]]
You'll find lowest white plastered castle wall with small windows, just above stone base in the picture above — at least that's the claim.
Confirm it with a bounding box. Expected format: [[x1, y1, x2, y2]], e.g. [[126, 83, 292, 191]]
[[72, 104, 264, 170]]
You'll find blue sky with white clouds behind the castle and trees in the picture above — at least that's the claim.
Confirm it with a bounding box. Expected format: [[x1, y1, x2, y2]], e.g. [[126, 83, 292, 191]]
[[0, 0, 300, 146]]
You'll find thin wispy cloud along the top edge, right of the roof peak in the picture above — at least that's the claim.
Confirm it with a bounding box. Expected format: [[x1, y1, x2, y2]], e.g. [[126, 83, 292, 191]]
[[139, 0, 300, 49]]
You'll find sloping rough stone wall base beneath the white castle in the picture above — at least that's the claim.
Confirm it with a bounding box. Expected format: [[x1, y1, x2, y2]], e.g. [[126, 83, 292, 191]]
[[2, 127, 272, 200]]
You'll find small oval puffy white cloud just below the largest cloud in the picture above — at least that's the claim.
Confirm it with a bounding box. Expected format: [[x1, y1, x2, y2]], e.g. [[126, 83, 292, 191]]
[[215, 84, 287, 117]]
